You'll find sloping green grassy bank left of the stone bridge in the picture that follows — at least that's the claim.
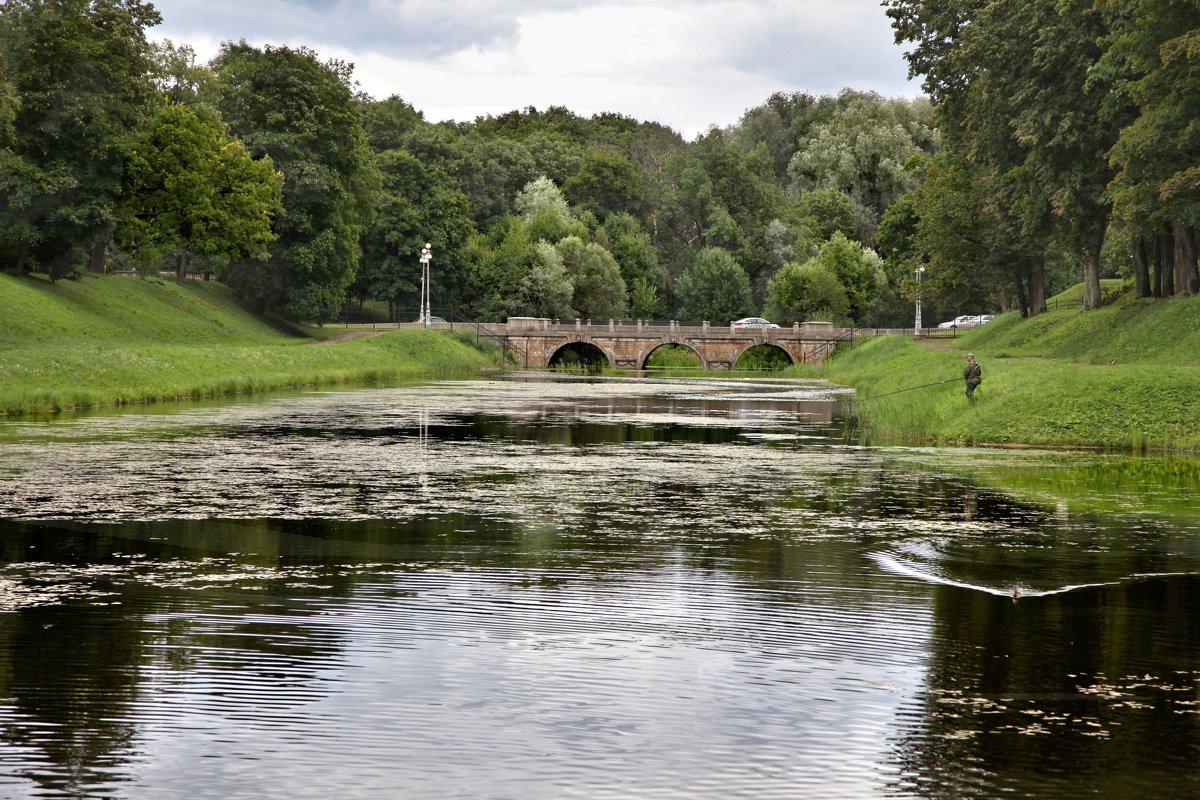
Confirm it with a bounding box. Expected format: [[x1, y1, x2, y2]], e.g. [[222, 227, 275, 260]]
[[0, 275, 499, 415]]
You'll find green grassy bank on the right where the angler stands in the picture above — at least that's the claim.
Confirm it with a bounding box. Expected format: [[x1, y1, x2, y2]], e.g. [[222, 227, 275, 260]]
[[793, 282, 1200, 451]]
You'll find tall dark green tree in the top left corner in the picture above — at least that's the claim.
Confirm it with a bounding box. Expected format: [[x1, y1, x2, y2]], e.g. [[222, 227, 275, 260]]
[[0, 0, 160, 277]]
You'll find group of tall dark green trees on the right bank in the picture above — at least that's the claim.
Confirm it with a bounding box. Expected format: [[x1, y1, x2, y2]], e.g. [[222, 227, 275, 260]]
[[882, 0, 1200, 313]]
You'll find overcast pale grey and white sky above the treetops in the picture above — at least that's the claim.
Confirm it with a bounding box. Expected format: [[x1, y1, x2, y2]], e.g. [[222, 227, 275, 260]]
[[150, 0, 920, 139]]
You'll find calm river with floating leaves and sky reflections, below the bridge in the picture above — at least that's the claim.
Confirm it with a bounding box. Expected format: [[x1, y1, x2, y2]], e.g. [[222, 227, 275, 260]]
[[0, 379, 1200, 800]]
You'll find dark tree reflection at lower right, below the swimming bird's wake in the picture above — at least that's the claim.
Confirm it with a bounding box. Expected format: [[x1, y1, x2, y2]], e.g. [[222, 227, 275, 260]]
[[895, 576, 1200, 800]]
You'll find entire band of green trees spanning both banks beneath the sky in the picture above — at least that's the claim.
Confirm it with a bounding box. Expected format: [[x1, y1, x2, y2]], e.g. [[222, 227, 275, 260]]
[[9, 0, 1185, 326]]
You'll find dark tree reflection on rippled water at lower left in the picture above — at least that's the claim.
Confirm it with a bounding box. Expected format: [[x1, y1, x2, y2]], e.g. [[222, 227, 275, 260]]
[[0, 521, 436, 796]]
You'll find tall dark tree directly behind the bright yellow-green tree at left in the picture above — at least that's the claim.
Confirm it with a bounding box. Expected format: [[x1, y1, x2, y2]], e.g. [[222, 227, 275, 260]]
[[214, 42, 378, 321]]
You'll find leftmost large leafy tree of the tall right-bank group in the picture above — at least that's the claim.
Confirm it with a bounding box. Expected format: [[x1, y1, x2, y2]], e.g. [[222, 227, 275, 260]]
[[884, 0, 1171, 313]]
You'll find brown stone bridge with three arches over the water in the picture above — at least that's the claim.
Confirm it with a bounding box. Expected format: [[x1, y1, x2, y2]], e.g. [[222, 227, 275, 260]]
[[487, 317, 853, 369]]
